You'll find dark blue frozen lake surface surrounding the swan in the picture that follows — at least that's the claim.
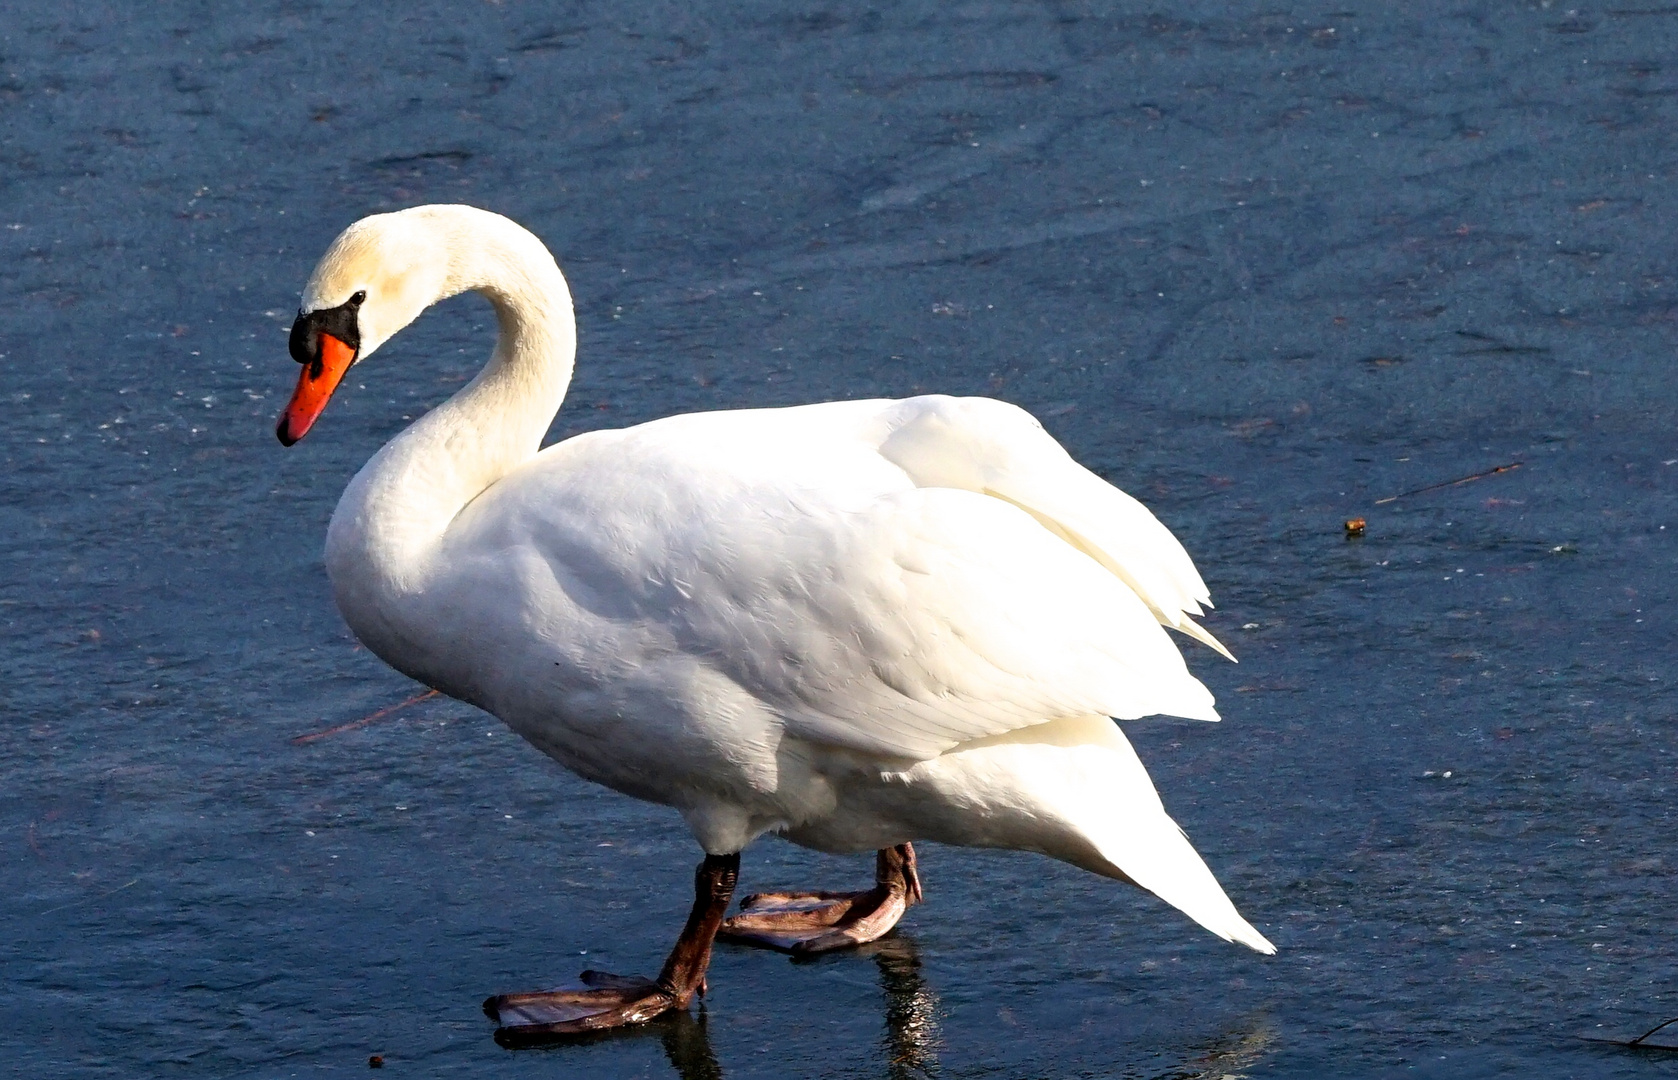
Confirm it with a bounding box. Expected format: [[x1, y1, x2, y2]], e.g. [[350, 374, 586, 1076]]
[[0, 0, 1678, 1078]]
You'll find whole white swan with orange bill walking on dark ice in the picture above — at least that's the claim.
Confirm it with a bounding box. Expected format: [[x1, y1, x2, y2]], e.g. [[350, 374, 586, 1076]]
[[279, 206, 1274, 1038]]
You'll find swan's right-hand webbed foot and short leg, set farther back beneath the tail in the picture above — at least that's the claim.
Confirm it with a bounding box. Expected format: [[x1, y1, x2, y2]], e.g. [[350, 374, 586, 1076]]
[[718, 844, 921, 954]]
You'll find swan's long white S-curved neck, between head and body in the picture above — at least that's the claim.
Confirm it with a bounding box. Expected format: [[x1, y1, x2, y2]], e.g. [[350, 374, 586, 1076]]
[[326, 215, 577, 617]]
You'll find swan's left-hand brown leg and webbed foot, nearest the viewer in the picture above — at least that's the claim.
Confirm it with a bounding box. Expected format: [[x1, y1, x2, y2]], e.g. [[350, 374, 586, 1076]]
[[483, 852, 740, 1046]]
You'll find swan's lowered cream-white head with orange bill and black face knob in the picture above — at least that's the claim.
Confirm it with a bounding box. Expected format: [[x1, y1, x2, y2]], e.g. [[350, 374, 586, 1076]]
[[275, 206, 455, 446]]
